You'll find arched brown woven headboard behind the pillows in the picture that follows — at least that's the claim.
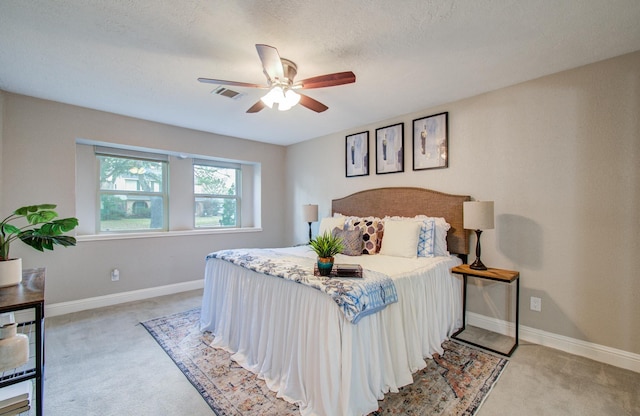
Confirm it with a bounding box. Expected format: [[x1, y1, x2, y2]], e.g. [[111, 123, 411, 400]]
[[331, 187, 471, 255]]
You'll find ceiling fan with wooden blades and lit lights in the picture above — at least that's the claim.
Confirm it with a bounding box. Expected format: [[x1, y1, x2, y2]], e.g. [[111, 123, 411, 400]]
[[198, 44, 356, 113]]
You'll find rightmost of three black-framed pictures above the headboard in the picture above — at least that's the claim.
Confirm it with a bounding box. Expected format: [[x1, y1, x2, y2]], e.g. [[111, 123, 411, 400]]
[[413, 113, 449, 170]]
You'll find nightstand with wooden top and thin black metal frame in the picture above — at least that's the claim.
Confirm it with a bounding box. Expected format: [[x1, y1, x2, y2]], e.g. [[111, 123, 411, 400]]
[[451, 264, 520, 357]]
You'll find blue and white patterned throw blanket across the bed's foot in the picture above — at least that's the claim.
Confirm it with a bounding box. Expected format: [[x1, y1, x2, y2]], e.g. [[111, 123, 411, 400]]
[[207, 249, 398, 324]]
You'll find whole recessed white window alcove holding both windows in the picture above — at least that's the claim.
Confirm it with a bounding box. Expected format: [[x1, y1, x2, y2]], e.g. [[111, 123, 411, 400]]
[[76, 139, 262, 236]]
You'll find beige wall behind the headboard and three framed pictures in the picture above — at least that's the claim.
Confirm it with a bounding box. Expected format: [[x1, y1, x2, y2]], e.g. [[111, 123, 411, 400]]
[[287, 52, 640, 354]]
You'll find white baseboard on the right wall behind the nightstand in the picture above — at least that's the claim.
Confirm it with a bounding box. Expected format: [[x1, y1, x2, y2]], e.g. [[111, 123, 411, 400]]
[[467, 312, 640, 373]]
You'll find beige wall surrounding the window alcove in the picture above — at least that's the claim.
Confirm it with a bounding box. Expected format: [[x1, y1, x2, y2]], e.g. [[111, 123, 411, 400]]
[[1, 93, 286, 304]]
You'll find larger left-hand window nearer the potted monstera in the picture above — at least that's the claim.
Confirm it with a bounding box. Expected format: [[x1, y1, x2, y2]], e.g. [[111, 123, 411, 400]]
[[96, 147, 168, 232]]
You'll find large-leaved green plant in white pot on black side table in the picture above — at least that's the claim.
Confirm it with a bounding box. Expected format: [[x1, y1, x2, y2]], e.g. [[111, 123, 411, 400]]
[[0, 204, 78, 287]]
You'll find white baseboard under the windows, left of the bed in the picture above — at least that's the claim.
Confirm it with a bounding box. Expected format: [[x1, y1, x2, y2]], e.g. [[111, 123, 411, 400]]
[[44, 279, 204, 316]]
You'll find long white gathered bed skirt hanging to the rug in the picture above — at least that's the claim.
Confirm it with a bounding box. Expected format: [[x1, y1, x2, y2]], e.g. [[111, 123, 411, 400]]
[[201, 257, 462, 416]]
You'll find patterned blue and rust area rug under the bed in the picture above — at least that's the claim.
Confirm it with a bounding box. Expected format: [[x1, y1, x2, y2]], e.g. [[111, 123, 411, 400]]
[[142, 309, 508, 416]]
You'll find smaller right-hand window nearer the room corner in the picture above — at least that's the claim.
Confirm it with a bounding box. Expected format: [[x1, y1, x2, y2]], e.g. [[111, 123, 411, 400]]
[[193, 159, 242, 228]]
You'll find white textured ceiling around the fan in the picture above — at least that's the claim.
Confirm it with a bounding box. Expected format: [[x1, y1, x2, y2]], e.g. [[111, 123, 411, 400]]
[[0, 0, 640, 145]]
